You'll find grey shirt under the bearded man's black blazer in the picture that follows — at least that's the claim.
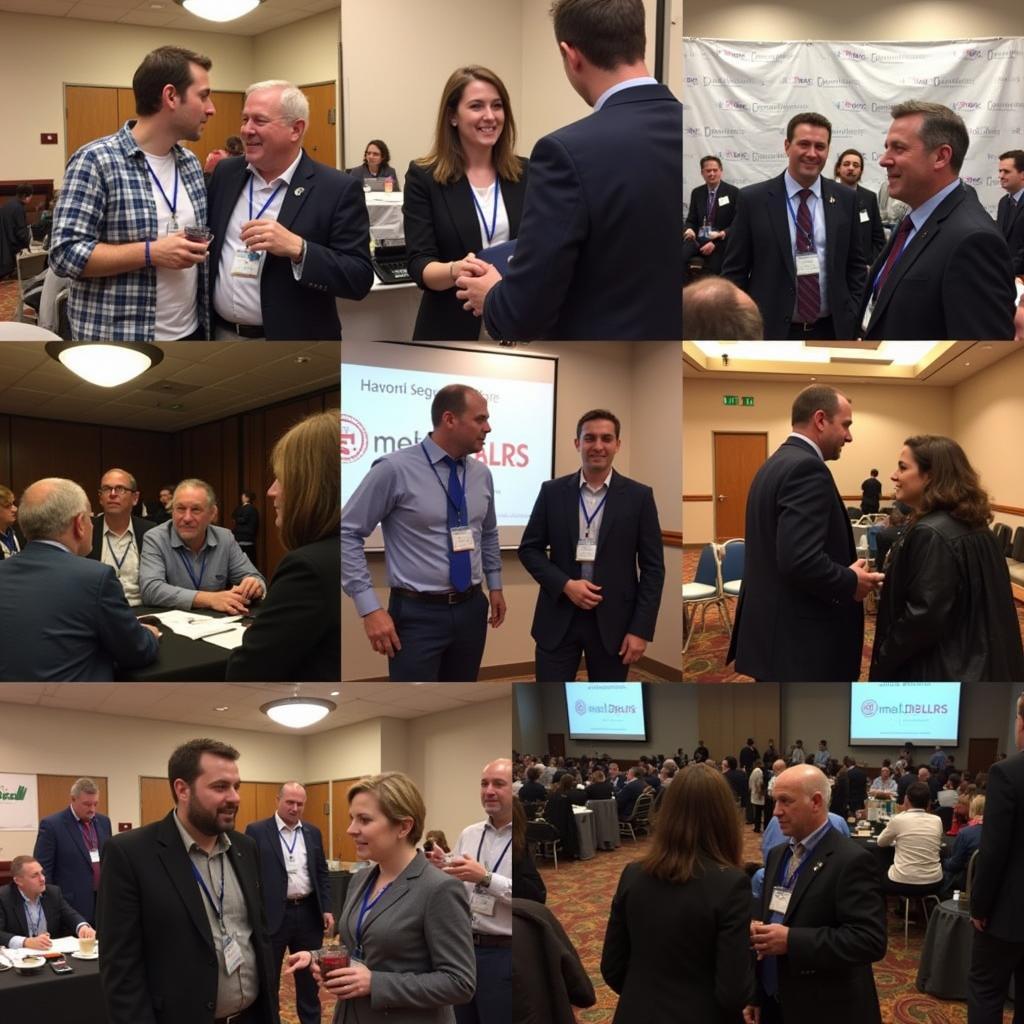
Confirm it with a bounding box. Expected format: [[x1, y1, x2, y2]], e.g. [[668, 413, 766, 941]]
[[173, 806, 259, 1017]]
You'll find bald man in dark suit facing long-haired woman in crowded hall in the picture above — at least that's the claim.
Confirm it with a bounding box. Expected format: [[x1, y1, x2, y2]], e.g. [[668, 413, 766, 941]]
[[743, 765, 887, 1024]]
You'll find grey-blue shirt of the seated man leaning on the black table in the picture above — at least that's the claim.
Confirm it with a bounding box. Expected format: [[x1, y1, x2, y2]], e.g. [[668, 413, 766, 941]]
[[138, 520, 266, 611]]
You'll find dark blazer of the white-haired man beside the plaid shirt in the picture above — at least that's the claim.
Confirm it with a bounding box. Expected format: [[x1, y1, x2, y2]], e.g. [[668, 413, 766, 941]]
[[210, 153, 374, 341]]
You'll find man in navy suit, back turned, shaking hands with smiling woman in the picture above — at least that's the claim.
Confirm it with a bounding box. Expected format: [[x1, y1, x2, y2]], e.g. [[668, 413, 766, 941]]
[[458, 0, 683, 340]]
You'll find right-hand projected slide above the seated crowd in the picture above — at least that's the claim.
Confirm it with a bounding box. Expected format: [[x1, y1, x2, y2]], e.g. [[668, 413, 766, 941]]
[[850, 683, 961, 746]]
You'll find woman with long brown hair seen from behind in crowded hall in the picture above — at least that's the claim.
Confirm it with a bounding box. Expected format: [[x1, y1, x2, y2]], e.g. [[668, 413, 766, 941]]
[[601, 764, 754, 1024]]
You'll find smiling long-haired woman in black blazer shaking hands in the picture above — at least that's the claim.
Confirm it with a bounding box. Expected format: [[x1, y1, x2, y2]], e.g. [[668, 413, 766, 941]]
[[403, 65, 527, 341]]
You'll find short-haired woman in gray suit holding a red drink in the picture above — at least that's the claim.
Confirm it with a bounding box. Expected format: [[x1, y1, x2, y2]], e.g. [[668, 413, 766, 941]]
[[285, 772, 476, 1024]]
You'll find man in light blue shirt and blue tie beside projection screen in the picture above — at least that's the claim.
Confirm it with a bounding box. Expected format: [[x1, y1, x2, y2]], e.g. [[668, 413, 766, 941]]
[[341, 384, 505, 682]]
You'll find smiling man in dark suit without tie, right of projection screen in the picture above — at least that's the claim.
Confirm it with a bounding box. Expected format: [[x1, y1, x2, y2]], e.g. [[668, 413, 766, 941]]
[[519, 409, 665, 682]]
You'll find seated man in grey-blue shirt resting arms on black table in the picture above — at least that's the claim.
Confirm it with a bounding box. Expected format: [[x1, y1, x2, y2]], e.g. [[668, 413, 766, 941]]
[[138, 478, 266, 615]]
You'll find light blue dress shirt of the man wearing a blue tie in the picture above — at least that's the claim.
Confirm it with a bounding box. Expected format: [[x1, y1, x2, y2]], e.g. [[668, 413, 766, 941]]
[[342, 436, 502, 615]]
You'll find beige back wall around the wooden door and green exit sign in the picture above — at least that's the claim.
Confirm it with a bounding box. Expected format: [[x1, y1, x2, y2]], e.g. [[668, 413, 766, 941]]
[[683, 377, 953, 544]]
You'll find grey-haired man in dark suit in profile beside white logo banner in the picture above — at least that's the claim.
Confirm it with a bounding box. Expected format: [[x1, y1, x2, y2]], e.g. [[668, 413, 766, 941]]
[[858, 100, 1015, 341]]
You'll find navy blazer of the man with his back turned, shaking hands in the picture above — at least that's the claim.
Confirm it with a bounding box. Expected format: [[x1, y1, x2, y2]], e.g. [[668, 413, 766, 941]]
[[483, 85, 683, 341]]
